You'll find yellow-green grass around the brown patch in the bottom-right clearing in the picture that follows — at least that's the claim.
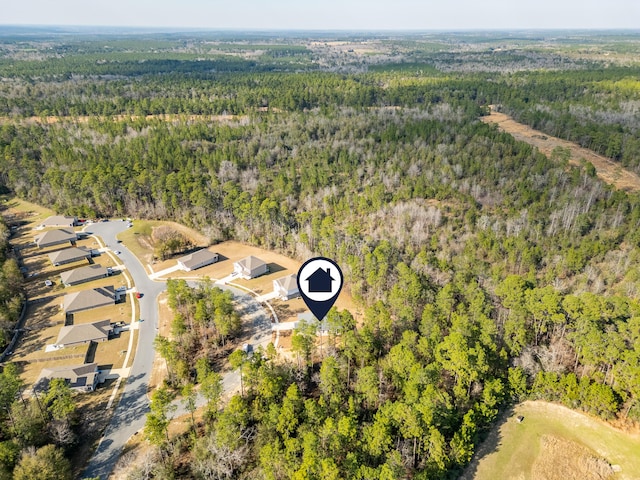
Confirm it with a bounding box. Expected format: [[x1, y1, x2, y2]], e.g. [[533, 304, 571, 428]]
[[461, 402, 640, 480]]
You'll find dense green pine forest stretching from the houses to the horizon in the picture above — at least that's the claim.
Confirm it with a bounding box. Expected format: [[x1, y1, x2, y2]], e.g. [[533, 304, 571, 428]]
[[0, 31, 640, 479]]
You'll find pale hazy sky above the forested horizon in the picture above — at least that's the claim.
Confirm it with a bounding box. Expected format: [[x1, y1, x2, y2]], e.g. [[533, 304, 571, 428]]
[[0, 0, 640, 30]]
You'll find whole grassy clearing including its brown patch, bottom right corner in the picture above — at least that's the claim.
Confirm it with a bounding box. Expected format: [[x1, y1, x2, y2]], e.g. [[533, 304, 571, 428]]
[[460, 401, 640, 480]]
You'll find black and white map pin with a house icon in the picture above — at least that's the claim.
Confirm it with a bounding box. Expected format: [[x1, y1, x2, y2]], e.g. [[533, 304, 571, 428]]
[[298, 257, 343, 321]]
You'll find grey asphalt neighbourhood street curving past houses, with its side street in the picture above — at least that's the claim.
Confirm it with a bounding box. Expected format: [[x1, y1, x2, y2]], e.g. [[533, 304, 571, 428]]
[[83, 221, 271, 480]]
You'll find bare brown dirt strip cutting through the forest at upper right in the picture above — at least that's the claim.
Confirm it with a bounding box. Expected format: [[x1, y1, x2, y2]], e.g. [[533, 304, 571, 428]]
[[482, 109, 640, 192]]
